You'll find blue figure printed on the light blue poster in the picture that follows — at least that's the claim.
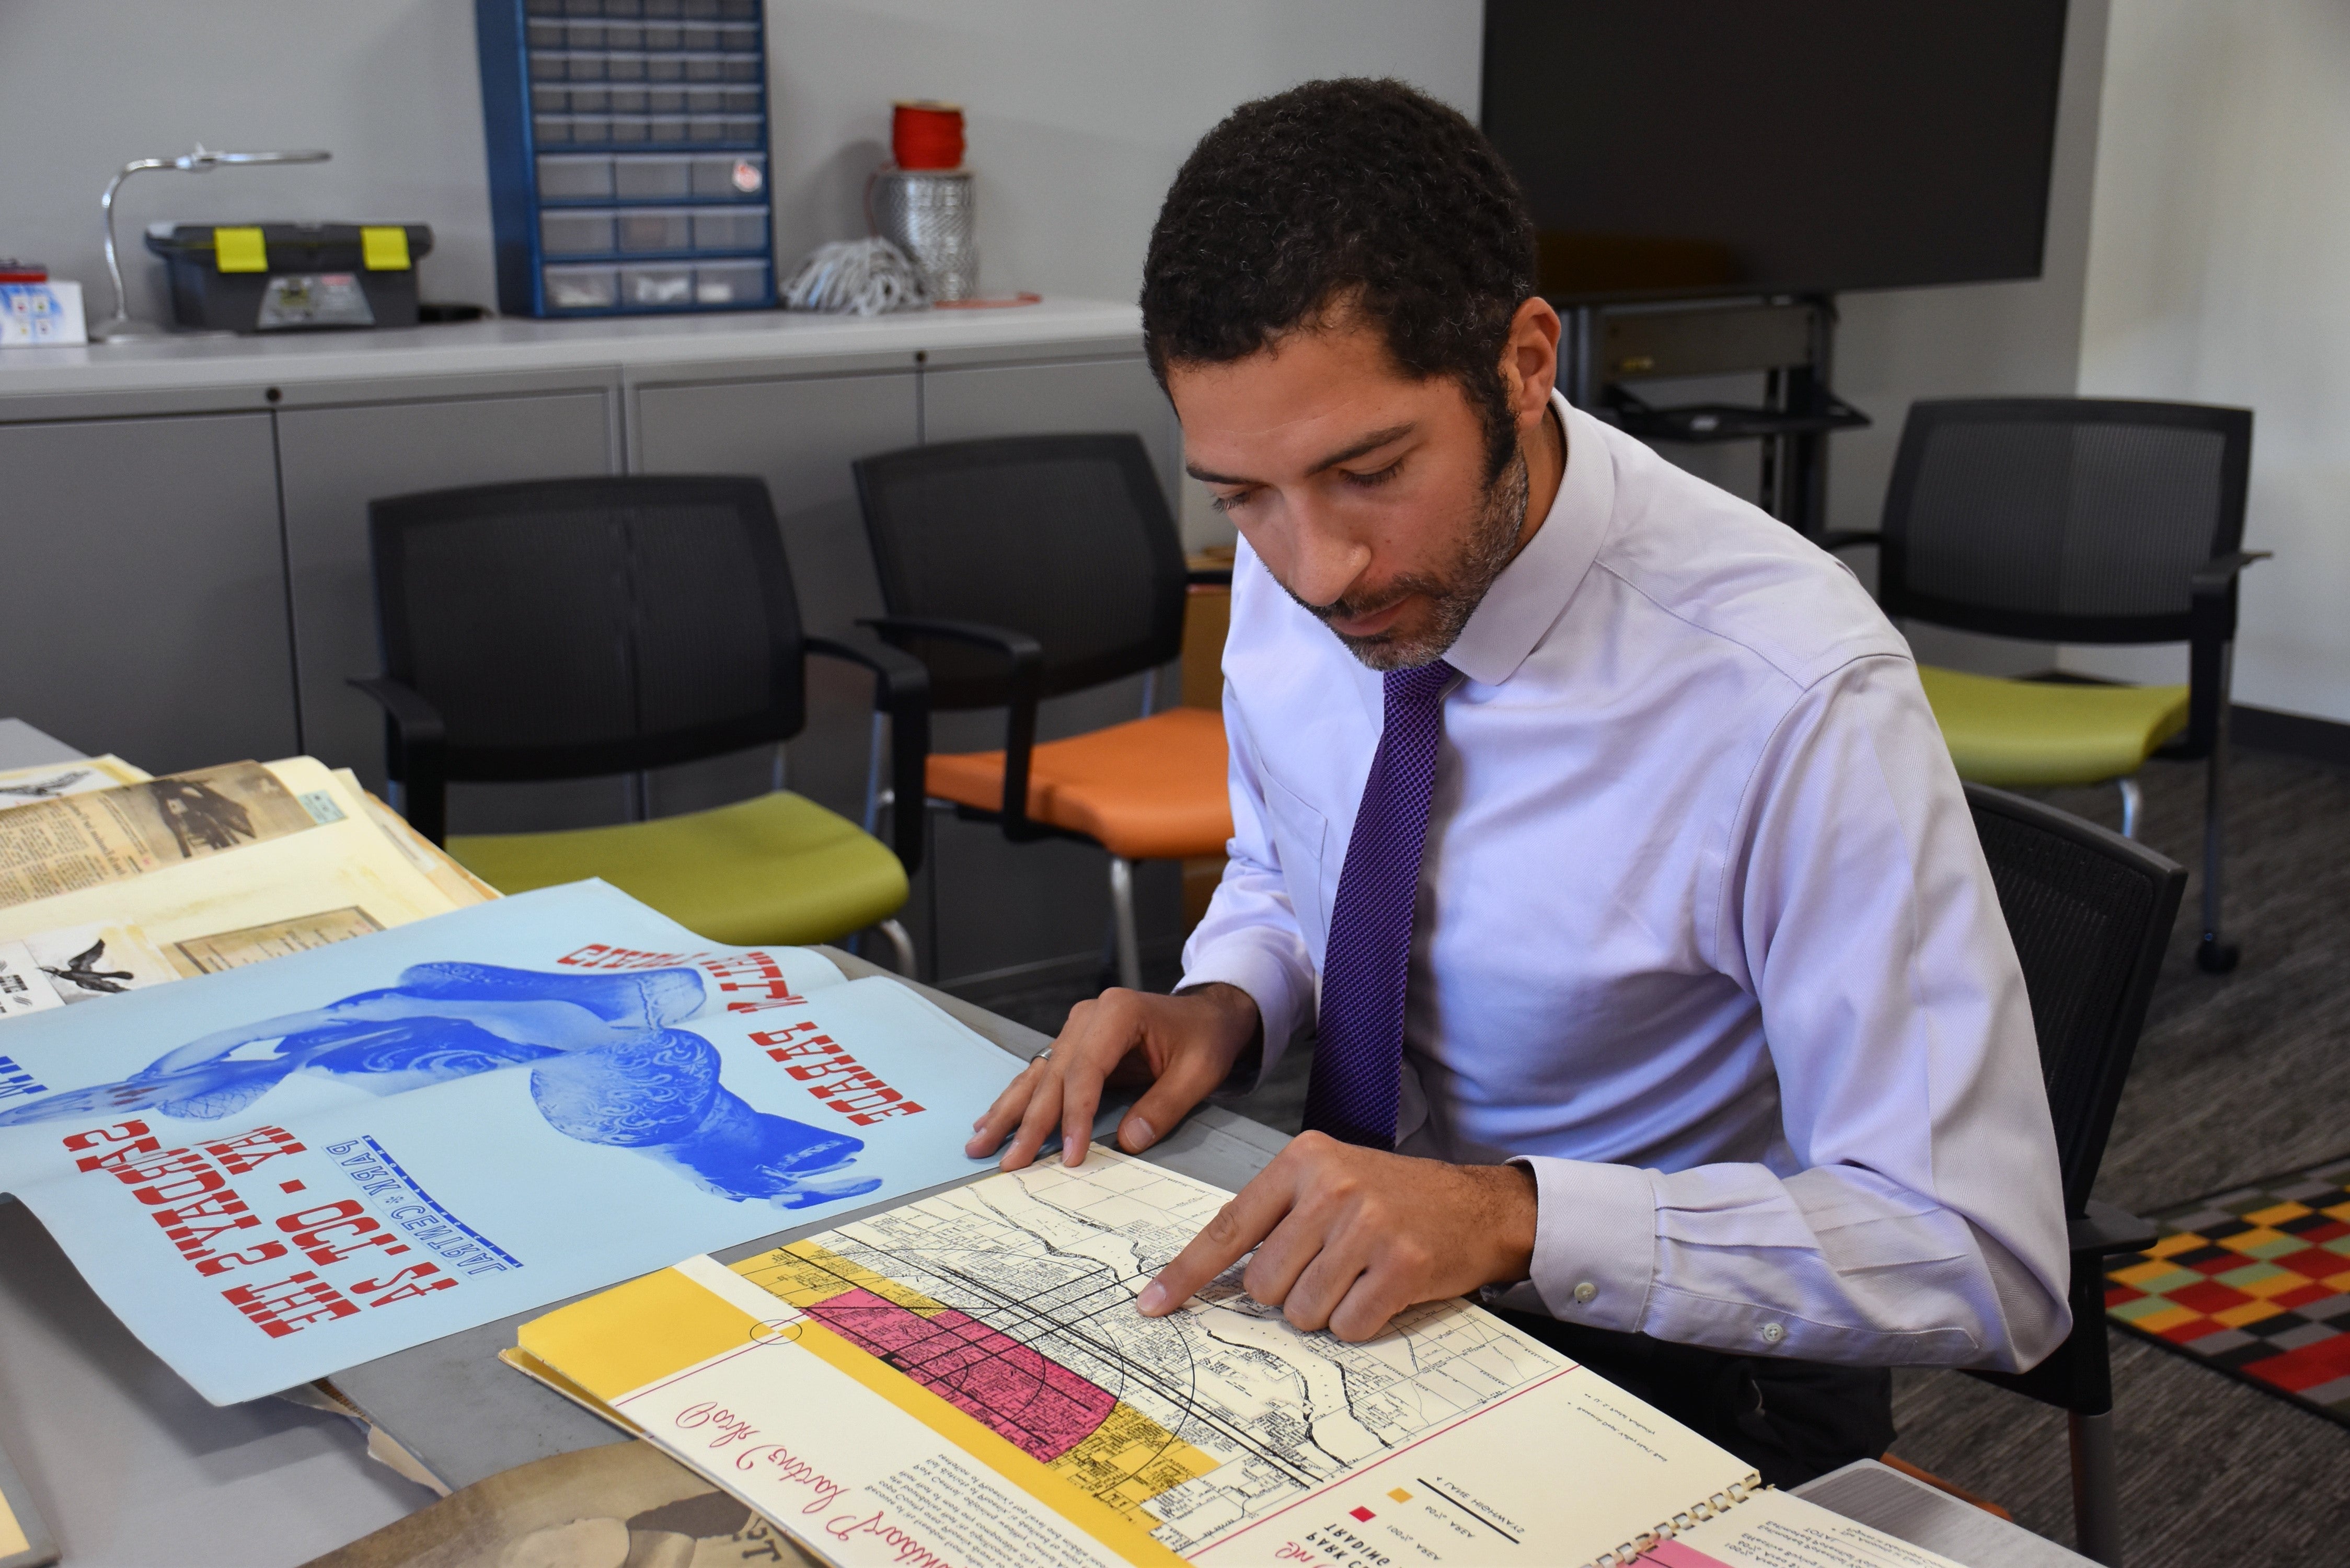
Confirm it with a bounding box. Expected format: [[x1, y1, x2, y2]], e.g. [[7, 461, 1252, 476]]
[[0, 962, 881, 1208]]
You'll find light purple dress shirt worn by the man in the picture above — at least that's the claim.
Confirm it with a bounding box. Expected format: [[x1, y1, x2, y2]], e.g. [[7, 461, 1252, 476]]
[[1184, 400, 2070, 1368]]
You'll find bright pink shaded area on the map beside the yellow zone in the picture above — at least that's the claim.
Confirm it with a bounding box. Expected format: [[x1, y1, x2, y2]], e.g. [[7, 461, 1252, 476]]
[[809, 1290, 1119, 1460]]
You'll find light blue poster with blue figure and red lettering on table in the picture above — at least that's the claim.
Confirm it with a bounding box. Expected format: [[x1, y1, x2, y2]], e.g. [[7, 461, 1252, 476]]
[[0, 882, 1018, 1403]]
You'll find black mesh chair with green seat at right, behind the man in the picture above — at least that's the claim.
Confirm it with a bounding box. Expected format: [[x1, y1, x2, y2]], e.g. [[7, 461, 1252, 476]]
[[1821, 397, 2268, 971]]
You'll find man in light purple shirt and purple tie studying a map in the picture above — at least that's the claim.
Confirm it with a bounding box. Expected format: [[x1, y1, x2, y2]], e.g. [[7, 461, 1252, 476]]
[[971, 82, 2068, 1483]]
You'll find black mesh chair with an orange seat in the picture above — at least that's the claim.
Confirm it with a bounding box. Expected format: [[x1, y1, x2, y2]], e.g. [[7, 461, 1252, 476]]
[[853, 433, 1231, 985]]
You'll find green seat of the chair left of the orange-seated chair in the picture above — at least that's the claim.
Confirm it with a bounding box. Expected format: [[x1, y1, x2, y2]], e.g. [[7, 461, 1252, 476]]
[[449, 790, 905, 948]]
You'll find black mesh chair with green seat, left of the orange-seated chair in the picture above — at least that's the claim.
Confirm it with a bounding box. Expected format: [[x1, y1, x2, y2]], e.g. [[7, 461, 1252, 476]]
[[352, 477, 928, 973]]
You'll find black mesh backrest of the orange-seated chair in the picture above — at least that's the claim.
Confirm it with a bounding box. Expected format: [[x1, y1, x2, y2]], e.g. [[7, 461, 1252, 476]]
[[853, 433, 1184, 708]]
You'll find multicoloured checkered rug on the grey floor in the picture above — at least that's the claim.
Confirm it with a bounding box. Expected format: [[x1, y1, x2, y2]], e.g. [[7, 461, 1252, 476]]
[[2105, 1159, 2350, 1427]]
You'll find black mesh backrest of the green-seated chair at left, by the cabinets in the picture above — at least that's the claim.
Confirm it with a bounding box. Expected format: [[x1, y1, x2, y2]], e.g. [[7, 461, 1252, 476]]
[[366, 477, 804, 780]]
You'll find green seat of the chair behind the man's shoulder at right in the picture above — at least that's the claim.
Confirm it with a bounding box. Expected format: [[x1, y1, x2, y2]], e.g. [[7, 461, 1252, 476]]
[[1918, 665, 2188, 790]]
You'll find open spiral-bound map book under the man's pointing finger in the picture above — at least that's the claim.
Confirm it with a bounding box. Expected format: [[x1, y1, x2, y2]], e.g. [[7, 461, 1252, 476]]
[[512, 1147, 1939, 1568]]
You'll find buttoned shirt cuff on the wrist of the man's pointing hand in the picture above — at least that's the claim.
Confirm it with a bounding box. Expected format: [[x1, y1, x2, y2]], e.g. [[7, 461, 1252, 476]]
[[1508, 1154, 1657, 1333]]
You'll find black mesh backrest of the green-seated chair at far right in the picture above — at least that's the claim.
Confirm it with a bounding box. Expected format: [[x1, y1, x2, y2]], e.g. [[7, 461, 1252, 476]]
[[1880, 397, 2251, 642]]
